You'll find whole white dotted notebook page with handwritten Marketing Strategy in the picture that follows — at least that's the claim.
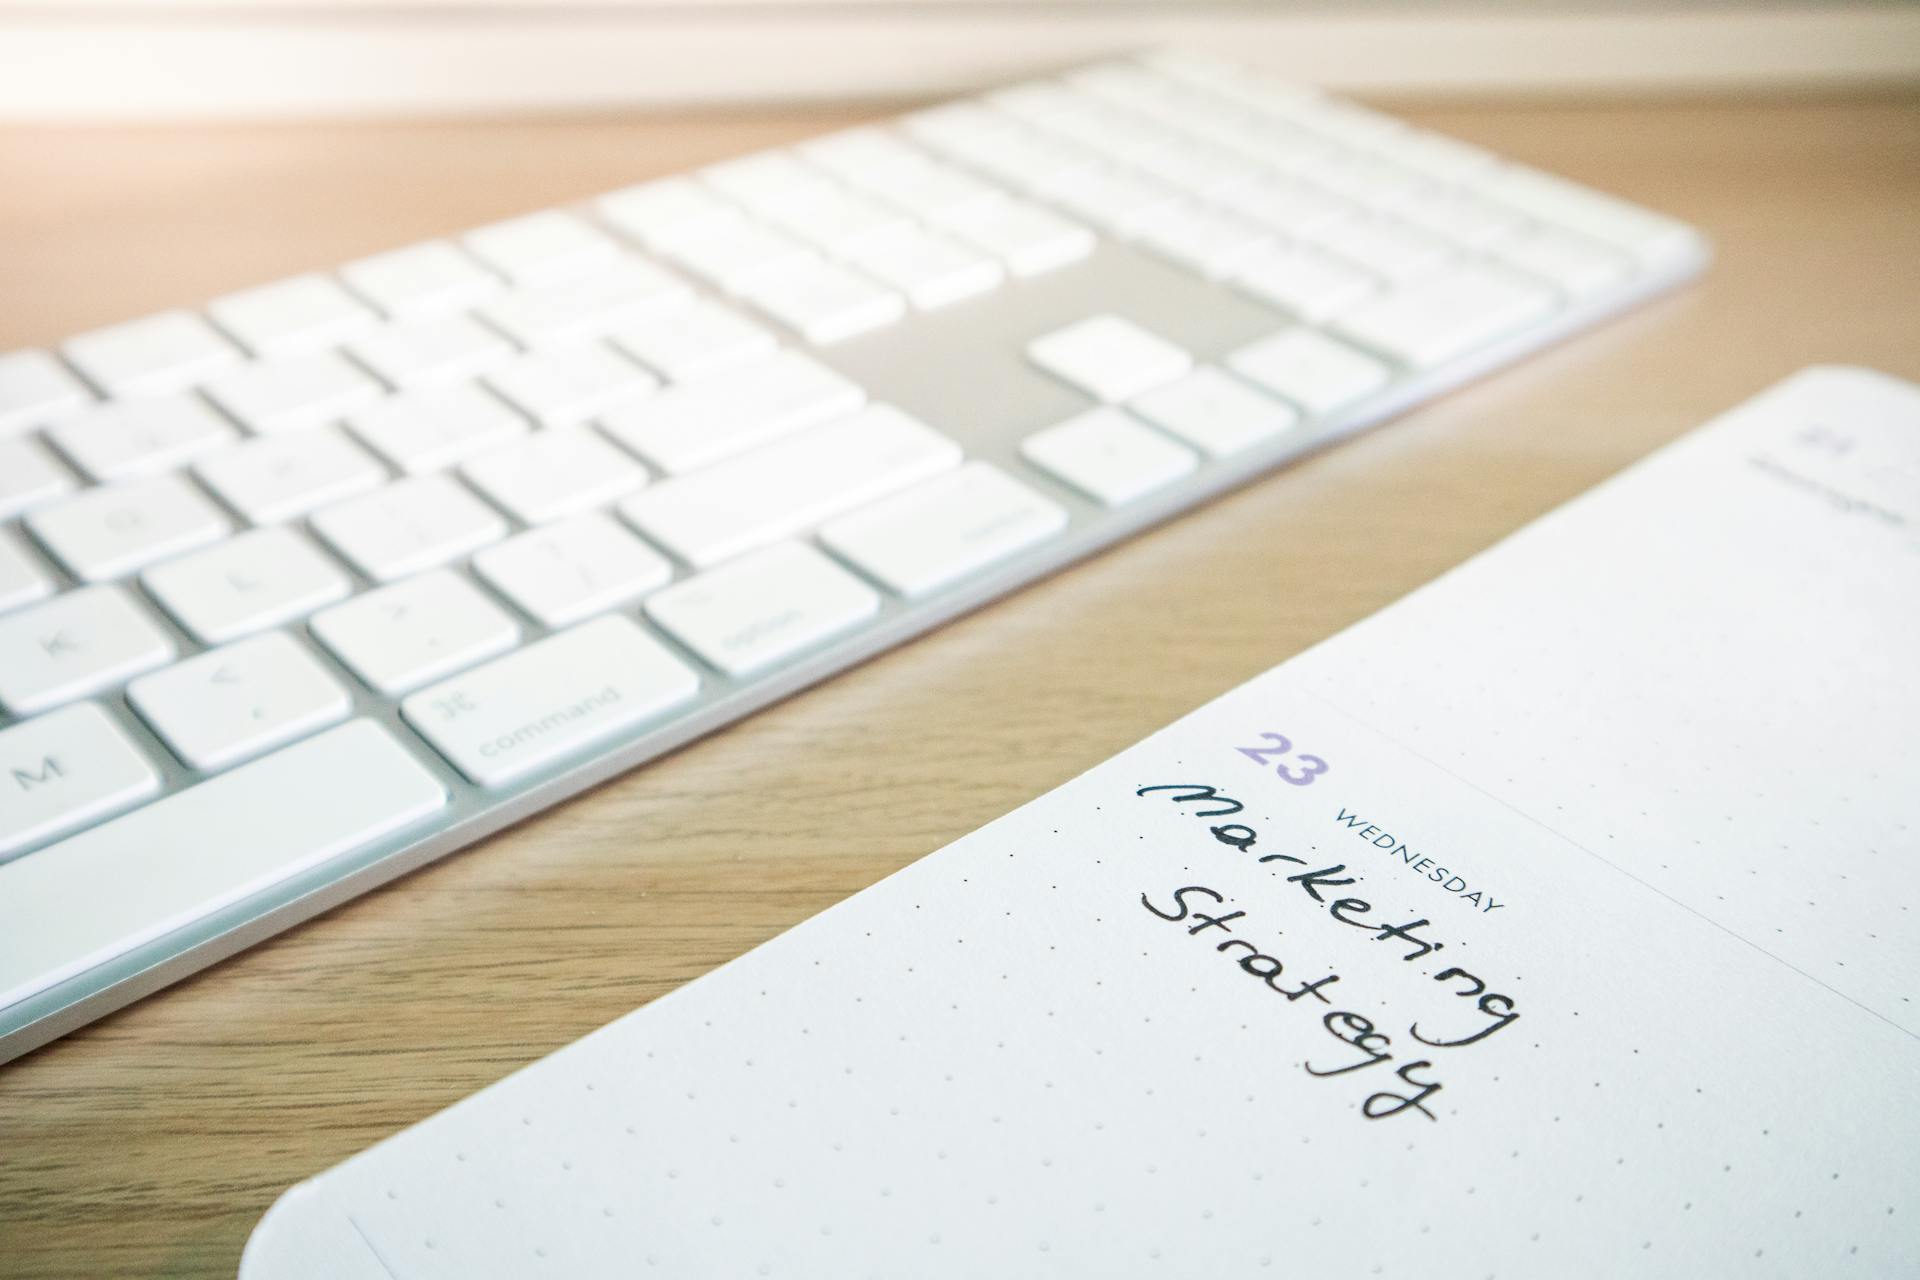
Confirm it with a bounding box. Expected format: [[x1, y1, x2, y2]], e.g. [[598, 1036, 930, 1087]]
[[242, 370, 1920, 1280]]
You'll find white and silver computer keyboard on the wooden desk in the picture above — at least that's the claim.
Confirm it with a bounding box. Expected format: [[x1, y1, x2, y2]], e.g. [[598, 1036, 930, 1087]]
[[0, 54, 1705, 1057]]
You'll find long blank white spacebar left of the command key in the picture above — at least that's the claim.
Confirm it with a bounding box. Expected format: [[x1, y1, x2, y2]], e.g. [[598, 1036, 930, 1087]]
[[0, 720, 447, 1009]]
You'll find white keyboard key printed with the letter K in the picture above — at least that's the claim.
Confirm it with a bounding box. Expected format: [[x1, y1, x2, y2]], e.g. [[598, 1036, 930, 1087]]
[[0, 587, 173, 716]]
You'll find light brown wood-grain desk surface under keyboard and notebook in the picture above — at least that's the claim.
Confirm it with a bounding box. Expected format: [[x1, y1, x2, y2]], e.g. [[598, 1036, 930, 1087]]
[[0, 96, 1920, 1280]]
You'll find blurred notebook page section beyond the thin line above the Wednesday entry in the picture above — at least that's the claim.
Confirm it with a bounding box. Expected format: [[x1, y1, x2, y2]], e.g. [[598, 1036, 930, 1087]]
[[1288, 370, 1920, 1034]]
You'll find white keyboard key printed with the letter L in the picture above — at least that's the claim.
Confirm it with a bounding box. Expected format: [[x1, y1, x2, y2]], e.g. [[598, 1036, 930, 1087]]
[[142, 528, 353, 645]]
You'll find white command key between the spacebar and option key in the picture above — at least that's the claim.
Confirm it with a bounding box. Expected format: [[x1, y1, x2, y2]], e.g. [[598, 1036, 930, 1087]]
[[401, 614, 701, 787]]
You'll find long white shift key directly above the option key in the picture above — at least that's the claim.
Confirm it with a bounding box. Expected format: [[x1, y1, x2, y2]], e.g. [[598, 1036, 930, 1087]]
[[620, 405, 960, 566]]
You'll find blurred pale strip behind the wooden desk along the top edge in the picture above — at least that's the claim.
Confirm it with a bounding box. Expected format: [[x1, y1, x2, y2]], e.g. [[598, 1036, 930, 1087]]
[[0, 0, 1920, 121]]
